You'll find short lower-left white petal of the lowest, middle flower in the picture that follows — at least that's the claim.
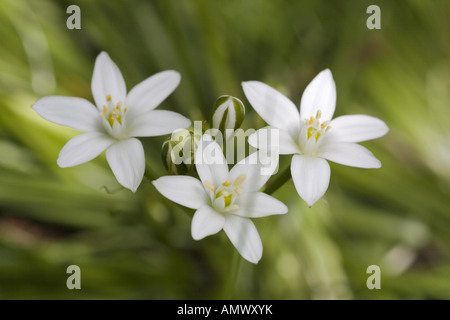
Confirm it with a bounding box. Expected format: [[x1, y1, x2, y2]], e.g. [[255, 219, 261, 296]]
[[191, 206, 225, 240]]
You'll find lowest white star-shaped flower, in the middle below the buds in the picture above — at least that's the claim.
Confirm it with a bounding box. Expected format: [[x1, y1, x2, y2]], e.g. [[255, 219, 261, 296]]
[[153, 135, 288, 263]]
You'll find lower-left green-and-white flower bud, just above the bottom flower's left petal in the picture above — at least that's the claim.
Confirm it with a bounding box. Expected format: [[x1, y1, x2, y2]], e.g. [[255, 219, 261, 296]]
[[161, 129, 201, 175]]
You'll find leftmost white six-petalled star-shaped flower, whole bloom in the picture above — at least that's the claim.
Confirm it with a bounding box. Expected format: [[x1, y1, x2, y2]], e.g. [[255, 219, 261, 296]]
[[32, 52, 191, 192]]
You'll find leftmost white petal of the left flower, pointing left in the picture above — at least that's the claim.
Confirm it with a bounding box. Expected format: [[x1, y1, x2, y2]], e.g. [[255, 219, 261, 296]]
[[32, 96, 100, 131]]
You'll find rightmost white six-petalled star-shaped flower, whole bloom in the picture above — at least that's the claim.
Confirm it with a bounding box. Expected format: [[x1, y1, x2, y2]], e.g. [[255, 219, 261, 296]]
[[242, 69, 389, 206]]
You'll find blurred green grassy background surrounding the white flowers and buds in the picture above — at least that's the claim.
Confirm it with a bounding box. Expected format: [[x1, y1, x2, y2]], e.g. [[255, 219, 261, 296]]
[[0, 0, 450, 299]]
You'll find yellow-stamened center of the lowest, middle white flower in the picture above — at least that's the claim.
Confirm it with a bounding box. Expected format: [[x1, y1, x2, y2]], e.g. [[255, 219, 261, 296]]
[[203, 174, 247, 213]]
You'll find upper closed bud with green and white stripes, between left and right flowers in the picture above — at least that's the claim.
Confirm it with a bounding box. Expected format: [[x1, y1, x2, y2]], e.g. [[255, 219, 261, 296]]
[[211, 96, 245, 132]]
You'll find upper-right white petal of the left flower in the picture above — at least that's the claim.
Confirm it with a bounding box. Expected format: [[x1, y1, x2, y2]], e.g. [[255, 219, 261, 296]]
[[126, 70, 181, 114]]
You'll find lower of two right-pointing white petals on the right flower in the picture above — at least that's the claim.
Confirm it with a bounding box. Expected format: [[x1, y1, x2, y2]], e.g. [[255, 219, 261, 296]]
[[319, 142, 381, 168]]
